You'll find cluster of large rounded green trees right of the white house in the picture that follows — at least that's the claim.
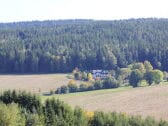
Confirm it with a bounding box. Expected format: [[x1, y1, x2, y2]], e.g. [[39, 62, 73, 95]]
[[128, 61, 163, 87]]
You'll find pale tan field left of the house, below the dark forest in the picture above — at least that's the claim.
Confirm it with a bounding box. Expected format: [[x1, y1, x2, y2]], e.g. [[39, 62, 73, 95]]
[[0, 74, 69, 93]]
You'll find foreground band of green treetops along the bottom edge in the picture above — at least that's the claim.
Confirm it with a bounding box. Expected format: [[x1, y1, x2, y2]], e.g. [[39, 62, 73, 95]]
[[0, 91, 168, 126]]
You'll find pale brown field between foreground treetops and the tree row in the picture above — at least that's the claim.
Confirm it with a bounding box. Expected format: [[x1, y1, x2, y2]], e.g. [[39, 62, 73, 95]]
[[46, 84, 168, 120]]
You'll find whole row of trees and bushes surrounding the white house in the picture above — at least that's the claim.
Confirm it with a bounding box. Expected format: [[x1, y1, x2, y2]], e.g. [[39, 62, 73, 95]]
[[55, 60, 165, 94]]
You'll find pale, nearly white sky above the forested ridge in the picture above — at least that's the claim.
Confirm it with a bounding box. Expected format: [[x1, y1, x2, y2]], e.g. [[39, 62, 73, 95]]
[[0, 0, 168, 22]]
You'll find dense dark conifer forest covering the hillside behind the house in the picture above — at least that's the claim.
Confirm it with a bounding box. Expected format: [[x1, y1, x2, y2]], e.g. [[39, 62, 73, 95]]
[[0, 19, 168, 73]]
